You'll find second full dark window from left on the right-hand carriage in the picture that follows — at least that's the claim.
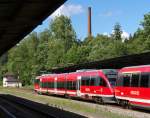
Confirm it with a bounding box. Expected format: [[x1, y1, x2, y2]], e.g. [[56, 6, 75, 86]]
[[131, 73, 140, 87]]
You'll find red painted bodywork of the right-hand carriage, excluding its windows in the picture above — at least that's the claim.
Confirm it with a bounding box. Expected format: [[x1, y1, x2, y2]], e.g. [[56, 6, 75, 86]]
[[115, 66, 150, 108]]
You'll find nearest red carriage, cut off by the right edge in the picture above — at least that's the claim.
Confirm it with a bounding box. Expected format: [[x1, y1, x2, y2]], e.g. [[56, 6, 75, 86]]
[[115, 65, 150, 109]]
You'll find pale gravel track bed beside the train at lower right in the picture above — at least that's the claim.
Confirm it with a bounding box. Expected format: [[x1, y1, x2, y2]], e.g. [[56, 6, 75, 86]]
[[70, 97, 150, 118]]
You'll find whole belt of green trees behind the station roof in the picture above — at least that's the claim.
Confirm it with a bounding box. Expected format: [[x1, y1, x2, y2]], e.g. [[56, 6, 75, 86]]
[[0, 13, 150, 85]]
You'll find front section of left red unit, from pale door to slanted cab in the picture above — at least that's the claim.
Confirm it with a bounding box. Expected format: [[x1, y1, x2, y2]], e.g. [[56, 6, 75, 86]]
[[78, 69, 117, 102]]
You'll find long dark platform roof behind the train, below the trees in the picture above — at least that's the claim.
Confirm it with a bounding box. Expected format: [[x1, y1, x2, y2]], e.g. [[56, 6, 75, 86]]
[[50, 52, 150, 73]]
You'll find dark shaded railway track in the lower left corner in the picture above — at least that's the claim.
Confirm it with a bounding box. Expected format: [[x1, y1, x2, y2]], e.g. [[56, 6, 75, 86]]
[[0, 95, 85, 118]]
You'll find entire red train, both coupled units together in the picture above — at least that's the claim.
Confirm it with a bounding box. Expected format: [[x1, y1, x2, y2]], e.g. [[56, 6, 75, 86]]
[[34, 65, 150, 109]]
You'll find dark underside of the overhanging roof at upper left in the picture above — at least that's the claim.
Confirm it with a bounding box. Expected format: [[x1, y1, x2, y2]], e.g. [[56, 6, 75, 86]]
[[0, 0, 66, 55]]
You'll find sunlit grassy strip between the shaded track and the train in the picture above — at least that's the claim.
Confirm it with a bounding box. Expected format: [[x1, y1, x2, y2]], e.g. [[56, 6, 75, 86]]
[[0, 87, 131, 118]]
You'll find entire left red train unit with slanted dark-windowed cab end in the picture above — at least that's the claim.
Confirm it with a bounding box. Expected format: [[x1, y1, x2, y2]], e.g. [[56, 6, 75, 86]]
[[34, 69, 117, 103]]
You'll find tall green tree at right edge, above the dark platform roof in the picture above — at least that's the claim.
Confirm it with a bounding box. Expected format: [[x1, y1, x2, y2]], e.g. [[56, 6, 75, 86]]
[[128, 12, 150, 54]]
